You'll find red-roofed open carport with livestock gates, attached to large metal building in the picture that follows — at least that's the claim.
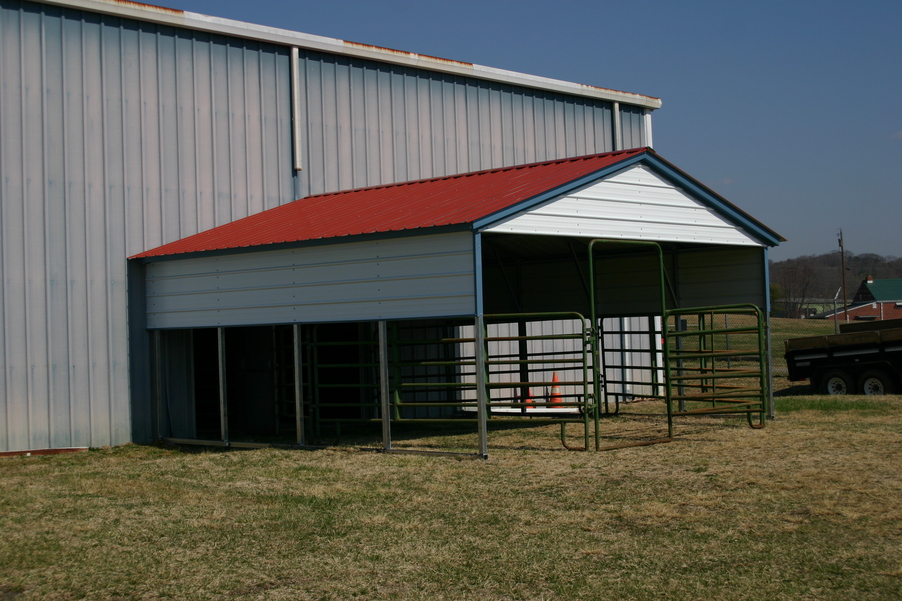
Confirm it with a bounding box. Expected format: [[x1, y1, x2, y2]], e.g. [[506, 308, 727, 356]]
[[130, 149, 782, 456]]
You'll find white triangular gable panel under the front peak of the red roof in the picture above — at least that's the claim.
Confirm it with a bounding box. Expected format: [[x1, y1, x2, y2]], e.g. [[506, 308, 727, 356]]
[[484, 166, 761, 246]]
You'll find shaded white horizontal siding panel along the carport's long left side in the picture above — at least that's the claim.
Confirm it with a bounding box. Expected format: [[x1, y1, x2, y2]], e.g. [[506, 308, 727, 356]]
[[147, 232, 476, 329]]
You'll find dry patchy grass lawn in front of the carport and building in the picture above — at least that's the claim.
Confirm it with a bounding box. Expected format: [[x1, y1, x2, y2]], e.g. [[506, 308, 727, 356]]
[[0, 397, 902, 600]]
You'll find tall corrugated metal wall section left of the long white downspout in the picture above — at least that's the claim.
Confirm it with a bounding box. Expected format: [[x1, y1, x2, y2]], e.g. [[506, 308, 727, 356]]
[[0, 0, 294, 450]]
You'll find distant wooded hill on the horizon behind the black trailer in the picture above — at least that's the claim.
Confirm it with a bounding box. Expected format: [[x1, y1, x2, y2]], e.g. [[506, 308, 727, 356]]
[[770, 252, 902, 304]]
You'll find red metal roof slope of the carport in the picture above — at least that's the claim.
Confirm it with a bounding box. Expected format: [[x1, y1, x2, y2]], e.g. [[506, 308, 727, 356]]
[[132, 148, 651, 259]]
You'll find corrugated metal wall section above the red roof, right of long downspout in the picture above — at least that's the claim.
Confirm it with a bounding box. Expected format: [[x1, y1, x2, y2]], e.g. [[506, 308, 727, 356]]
[[298, 50, 646, 196]]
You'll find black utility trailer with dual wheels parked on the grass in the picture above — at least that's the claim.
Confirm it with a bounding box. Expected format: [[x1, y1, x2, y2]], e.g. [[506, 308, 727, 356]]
[[786, 319, 902, 394]]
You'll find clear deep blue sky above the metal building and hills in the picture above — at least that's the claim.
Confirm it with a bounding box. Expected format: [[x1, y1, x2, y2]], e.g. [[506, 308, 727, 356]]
[[173, 0, 902, 260]]
